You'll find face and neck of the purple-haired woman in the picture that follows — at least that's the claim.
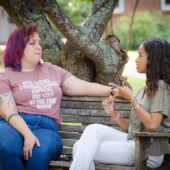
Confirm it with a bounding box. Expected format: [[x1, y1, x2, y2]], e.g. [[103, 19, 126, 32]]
[[22, 32, 42, 70]]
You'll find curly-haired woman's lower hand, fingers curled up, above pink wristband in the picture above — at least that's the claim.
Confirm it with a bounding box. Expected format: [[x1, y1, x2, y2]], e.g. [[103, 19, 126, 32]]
[[102, 96, 115, 116]]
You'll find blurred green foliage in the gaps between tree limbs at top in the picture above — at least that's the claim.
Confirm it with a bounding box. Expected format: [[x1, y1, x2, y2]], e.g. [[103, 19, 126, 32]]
[[48, 0, 92, 37]]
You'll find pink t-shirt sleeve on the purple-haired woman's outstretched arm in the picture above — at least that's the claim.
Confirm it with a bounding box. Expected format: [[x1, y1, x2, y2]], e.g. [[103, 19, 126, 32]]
[[45, 63, 72, 85]]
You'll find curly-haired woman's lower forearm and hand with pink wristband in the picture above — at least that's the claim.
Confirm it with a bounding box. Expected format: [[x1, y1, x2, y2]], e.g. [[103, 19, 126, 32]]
[[102, 96, 129, 132]]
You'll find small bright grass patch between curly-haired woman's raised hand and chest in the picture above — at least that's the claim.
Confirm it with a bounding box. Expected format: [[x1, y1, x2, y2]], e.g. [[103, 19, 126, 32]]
[[127, 77, 145, 96]]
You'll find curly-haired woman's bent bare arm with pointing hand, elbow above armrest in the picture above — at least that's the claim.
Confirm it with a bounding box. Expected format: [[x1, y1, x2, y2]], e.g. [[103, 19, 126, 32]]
[[110, 83, 163, 132]]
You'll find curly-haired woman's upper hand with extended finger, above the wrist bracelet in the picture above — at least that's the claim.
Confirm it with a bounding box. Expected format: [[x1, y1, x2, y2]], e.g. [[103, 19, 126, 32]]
[[109, 83, 134, 102]]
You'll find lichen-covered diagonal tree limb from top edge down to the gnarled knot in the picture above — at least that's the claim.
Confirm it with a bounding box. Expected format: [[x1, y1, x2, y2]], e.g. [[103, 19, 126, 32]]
[[35, 0, 127, 83]]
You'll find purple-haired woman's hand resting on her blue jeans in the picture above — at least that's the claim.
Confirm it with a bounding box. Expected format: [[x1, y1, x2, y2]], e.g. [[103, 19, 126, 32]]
[[23, 133, 40, 160]]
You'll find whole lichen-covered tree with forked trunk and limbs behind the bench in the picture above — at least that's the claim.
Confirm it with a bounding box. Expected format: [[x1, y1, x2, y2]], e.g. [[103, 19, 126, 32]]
[[0, 0, 127, 84]]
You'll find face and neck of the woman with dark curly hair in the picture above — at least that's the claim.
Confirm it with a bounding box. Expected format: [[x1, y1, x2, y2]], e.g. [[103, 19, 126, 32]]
[[136, 45, 148, 73]]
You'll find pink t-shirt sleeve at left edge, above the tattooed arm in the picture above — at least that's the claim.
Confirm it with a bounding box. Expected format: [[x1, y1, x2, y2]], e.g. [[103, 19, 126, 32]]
[[0, 72, 11, 94]]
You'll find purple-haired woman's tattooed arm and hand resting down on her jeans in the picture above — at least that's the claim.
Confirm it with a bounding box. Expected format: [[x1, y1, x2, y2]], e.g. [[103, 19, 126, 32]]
[[0, 92, 40, 160]]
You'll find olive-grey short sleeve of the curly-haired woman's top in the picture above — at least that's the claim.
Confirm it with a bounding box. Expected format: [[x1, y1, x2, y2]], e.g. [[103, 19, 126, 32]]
[[151, 81, 170, 116]]
